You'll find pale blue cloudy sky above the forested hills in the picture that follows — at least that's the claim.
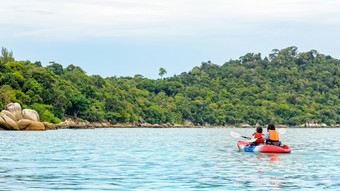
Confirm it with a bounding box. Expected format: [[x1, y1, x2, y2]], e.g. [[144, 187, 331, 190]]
[[0, 0, 340, 79]]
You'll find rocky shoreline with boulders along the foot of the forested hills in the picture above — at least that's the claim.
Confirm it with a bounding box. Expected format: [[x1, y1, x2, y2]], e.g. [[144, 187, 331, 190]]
[[0, 103, 340, 131]]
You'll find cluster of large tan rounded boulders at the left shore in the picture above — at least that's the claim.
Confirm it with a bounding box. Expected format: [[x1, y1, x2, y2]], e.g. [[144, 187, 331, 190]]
[[0, 103, 46, 131]]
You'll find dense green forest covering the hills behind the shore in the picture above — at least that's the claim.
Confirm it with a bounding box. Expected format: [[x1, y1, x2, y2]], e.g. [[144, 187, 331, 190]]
[[0, 46, 340, 125]]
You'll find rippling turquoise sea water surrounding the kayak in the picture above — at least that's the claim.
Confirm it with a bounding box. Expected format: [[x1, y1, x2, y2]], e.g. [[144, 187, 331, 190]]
[[0, 128, 340, 190]]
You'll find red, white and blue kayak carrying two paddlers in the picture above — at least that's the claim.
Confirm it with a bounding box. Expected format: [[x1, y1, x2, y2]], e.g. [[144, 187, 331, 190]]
[[237, 141, 291, 153]]
